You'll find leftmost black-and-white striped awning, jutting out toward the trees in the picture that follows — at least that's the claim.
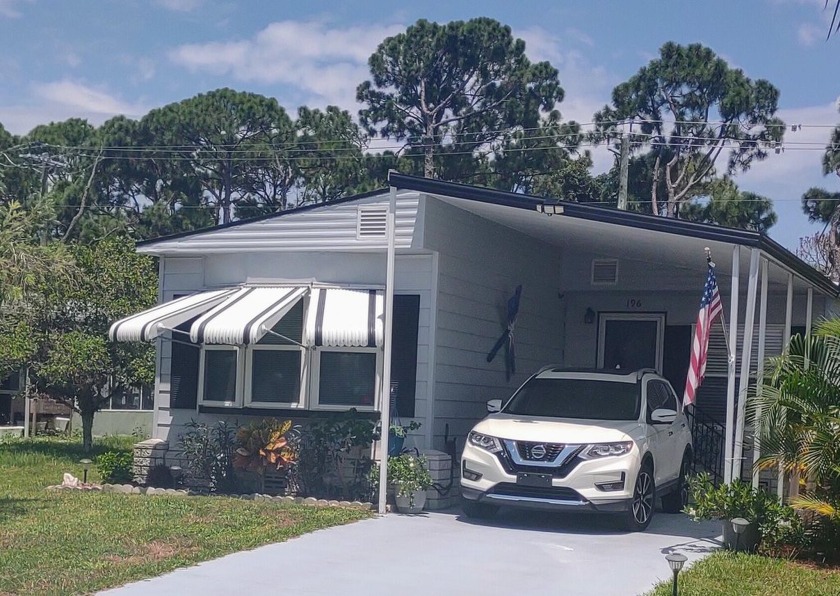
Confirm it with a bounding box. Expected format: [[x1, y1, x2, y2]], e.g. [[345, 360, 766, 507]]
[[108, 288, 236, 341]]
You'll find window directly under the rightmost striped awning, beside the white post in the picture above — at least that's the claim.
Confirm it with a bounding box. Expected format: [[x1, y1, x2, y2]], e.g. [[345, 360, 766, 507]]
[[313, 348, 381, 410]]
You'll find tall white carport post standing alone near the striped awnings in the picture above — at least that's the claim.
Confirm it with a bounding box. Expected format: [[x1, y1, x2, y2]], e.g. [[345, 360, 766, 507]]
[[378, 186, 397, 514]]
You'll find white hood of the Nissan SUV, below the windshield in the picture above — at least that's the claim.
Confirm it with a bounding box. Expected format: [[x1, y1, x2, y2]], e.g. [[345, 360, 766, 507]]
[[473, 414, 643, 443]]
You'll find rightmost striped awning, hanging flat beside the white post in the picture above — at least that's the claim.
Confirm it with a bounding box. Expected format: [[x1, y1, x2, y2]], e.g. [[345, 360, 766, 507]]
[[303, 288, 385, 347]]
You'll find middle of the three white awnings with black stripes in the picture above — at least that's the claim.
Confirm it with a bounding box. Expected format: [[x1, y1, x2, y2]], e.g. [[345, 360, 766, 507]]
[[190, 286, 309, 345]]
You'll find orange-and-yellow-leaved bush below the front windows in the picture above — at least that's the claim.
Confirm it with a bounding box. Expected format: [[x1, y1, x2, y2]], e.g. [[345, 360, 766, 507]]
[[233, 418, 299, 491]]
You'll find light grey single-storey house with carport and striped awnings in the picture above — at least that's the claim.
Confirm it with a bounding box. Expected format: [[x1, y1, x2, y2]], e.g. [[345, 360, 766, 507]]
[[111, 174, 837, 484]]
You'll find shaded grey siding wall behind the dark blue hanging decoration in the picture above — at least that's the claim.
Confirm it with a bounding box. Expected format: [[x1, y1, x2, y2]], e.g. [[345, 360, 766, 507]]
[[423, 198, 563, 449]]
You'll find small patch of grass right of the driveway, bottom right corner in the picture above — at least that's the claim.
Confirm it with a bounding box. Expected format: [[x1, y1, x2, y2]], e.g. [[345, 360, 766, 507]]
[[650, 551, 840, 596]]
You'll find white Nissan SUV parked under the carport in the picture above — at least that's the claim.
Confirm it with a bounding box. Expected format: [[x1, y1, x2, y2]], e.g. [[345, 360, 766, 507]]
[[461, 367, 692, 531]]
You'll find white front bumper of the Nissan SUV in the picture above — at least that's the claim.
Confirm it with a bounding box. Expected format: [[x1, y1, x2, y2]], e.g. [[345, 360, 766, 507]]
[[460, 444, 640, 513]]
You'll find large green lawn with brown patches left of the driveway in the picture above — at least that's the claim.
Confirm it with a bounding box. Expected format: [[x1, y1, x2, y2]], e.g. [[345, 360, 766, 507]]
[[0, 437, 370, 595]]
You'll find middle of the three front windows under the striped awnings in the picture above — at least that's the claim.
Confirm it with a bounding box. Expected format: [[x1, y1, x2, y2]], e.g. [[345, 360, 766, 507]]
[[246, 300, 305, 405]]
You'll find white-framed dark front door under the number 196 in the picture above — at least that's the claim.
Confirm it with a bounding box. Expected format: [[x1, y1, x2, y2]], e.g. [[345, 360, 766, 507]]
[[598, 313, 665, 373]]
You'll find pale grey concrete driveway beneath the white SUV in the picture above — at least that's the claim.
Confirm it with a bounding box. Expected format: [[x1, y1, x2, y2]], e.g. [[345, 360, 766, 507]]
[[104, 510, 720, 596]]
